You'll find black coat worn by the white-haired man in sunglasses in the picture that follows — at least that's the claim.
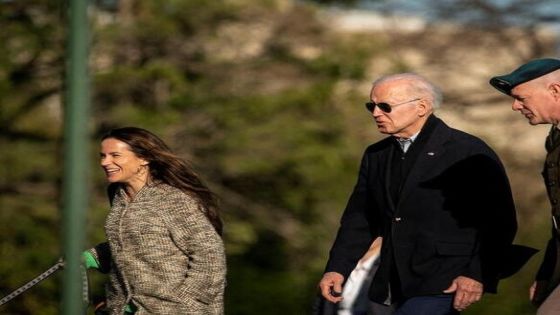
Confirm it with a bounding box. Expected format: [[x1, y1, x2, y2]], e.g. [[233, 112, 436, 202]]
[[325, 115, 517, 302]]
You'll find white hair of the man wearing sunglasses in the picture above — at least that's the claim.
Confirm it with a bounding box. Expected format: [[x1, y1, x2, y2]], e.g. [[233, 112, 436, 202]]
[[373, 72, 443, 108]]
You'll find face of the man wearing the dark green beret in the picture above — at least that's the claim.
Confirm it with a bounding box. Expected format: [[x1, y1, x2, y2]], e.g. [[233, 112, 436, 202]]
[[511, 79, 560, 125]]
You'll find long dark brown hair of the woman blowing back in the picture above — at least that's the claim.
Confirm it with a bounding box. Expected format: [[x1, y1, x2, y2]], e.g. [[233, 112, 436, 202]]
[[101, 127, 223, 235]]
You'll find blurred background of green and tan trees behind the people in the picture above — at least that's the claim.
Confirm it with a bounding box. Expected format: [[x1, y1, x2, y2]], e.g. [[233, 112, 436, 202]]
[[0, 0, 560, 315]]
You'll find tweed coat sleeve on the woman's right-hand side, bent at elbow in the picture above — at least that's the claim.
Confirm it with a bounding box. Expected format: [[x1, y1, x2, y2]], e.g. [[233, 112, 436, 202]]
[[160, 197, 226, 304]]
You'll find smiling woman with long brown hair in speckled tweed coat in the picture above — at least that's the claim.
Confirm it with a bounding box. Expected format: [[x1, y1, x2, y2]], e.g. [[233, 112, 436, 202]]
[[84, 127, 226, 315]]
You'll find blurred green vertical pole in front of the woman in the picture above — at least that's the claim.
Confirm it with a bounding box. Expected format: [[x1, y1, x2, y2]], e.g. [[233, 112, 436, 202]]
[[62, 0, 89, 315]]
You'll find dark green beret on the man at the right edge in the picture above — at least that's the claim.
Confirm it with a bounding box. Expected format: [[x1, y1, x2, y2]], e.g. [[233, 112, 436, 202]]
[[490, 58, 560, 95]]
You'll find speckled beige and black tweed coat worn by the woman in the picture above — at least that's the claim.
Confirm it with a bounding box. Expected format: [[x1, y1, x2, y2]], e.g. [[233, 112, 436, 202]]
[[91, 183, 226, 315]]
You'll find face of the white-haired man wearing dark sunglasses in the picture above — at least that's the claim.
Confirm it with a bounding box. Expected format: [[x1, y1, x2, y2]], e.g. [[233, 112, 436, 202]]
[[370, 80, 425, 138]]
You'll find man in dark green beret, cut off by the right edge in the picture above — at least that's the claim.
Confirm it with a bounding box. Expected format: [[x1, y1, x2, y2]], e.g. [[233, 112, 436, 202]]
[[490, 58, 560, 315]]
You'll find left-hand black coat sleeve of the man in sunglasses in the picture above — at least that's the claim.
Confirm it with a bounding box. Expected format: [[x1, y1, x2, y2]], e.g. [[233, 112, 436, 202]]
[[325, 151, 379, 279]]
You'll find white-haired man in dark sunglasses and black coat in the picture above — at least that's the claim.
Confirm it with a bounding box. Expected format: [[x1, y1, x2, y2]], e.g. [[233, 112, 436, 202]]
[[319, 73, 517, 315]]
